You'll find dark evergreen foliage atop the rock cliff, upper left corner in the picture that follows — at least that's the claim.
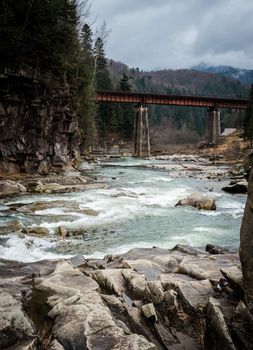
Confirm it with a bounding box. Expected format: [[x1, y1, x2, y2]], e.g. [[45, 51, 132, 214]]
[[0, 0, 78, 79]]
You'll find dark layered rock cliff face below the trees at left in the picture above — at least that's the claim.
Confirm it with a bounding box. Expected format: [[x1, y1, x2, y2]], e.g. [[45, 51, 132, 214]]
[[0, 74, 80, 174]]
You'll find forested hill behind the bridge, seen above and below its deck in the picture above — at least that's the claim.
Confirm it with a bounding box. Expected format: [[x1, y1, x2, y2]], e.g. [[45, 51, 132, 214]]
[[108, 60, 249, 143]]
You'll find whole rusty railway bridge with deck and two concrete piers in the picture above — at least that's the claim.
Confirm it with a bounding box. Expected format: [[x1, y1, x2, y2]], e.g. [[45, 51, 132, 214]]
[[96, 91, 248, 157]]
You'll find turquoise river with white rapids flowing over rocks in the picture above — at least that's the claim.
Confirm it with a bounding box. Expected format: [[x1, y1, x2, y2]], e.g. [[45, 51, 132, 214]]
[[0, 158, 246, 261]]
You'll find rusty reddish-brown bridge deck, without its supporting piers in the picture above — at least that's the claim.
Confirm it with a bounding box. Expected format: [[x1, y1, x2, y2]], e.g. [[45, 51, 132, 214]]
[[96, 91, 248, 109]]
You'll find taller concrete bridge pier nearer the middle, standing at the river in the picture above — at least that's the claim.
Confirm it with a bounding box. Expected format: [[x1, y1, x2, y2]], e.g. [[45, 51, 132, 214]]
[[133, 105, 150, 158]]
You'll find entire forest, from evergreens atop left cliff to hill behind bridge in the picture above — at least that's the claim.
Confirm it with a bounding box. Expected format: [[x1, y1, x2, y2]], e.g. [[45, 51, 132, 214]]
[[0, 0, 248, 149]]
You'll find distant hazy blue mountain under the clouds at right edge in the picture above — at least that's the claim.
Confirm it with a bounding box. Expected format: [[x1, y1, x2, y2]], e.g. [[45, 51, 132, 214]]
[[192, 63, 253, 85]]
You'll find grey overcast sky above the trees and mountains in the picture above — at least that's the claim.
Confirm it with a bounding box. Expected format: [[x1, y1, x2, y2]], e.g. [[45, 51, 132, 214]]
[[90, 0, 253, 70]]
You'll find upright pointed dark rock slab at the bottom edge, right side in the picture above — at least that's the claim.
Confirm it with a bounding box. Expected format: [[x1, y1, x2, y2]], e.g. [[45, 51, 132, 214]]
[[204, 298, 236, 350]]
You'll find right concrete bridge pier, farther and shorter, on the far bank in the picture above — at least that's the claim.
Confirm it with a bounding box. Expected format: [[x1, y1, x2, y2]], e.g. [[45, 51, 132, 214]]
[[206, 108, 221, 145]]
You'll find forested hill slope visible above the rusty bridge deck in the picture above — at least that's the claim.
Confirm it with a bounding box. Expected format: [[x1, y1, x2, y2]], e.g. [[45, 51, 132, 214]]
[[108, 60, 249, 98]]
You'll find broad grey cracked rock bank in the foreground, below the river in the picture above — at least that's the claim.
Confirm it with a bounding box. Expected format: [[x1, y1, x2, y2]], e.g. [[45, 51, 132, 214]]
[[0, 245, 253, 350]]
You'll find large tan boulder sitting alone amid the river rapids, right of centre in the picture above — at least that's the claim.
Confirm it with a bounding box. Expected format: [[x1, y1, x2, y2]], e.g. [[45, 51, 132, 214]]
[[176, 193, 216, 210]]
